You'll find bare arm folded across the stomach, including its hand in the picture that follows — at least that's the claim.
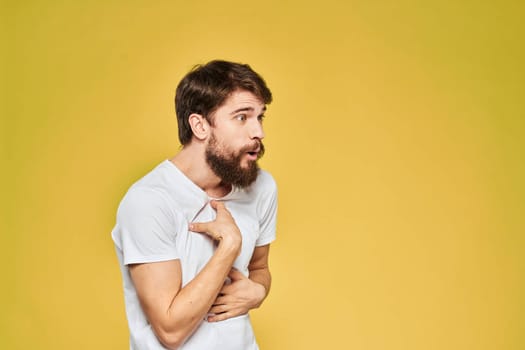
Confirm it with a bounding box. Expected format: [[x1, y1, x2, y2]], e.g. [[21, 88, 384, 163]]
[[208, 244, 272, 322]]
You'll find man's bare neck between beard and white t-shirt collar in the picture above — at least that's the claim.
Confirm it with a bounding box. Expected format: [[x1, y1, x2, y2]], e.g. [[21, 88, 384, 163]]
[[170, 144, 231, 198]]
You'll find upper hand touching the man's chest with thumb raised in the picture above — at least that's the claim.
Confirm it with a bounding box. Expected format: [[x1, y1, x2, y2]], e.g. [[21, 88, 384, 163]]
[[189, 201, 242, 251]]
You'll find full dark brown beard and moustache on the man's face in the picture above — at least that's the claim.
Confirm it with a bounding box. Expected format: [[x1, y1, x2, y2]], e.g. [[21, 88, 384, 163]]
[[206, 133, 264, 188]]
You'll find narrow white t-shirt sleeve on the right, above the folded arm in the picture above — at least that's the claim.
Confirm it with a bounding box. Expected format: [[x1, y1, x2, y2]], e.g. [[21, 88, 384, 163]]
[[255, 178, 277, 246]]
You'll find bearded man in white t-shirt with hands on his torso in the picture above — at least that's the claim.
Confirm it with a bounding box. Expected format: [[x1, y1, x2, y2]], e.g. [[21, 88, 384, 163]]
[[112, 61, 277, 350]]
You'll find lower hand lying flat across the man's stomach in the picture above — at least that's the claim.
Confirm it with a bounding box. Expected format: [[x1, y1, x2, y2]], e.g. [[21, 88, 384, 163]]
[[208, 268, 266, 322]]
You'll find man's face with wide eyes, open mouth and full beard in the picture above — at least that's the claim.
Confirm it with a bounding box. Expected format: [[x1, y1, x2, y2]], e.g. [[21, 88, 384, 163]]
[[206, 91, 266, 187]]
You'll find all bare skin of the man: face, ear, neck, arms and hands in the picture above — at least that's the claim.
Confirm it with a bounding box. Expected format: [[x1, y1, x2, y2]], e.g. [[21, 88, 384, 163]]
[[129, 91, 271, 349]]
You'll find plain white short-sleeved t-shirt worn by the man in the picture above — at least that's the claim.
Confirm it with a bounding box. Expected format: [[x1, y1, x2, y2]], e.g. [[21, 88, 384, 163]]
[[111, 160, 277, 350]]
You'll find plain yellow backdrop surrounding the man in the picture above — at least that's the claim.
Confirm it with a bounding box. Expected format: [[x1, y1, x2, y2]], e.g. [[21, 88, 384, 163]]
[[0, 0, 525, 350]]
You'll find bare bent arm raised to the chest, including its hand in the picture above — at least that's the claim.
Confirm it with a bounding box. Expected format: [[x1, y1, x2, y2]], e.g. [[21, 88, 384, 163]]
[[129, 201, 242, 349]]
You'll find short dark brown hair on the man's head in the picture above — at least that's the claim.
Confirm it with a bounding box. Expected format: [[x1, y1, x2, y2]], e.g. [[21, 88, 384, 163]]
[[175, 60, 272, 145]]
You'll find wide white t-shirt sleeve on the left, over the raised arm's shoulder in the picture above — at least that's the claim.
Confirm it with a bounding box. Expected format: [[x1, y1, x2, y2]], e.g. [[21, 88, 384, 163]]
[[117, 189, 179, 265]]
